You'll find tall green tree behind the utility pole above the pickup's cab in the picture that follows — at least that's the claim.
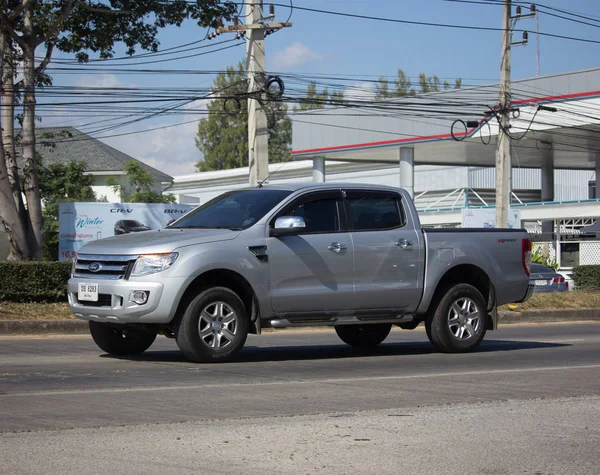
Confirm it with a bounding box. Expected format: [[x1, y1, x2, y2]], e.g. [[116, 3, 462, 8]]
[[196, 62, 292, 171]]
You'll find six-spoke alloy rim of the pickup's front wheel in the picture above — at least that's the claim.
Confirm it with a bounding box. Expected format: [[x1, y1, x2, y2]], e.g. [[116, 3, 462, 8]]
[[198, 301, 238, 350]]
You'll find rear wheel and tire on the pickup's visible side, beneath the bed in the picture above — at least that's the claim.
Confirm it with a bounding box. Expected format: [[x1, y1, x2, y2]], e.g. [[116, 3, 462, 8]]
[[425, 284, 487, 353]]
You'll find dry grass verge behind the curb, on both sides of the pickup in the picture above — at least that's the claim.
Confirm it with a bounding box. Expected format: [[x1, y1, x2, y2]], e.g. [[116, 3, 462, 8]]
[[0, 290, 600, 320]]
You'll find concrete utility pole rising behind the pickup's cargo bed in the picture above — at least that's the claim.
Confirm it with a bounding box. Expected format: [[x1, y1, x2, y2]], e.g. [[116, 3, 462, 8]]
[[496, 0, 512, 228]]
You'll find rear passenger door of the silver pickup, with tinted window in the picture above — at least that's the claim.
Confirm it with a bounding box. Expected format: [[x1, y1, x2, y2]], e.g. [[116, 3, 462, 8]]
[[345, 190, 424, 311]]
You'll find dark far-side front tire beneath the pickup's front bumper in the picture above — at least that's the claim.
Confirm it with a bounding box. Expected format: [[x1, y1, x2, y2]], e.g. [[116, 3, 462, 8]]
[[90, 321, 156, 356]]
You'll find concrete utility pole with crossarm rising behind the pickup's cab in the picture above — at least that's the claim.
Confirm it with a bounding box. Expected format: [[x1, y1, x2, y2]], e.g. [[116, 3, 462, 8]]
[[216, 0, 292, 186]]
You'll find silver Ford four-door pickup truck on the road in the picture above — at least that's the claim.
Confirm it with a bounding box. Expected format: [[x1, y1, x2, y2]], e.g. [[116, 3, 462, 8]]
[[68, 183, 533, 362]]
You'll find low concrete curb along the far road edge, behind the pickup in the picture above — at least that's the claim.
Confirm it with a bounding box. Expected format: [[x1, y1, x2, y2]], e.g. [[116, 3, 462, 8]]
[[0, 308, 600, 335]]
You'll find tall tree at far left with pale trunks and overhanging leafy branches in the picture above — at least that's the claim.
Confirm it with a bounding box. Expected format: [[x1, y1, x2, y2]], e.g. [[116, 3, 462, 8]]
[[0, 0, 236, 260]]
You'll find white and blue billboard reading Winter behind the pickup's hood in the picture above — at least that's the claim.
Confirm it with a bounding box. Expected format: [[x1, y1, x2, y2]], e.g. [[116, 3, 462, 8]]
[[58, 203, 196, 261]]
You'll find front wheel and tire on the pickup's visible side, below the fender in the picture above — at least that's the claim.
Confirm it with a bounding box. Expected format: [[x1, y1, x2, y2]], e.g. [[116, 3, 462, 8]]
[[176, 287, 249, 363]]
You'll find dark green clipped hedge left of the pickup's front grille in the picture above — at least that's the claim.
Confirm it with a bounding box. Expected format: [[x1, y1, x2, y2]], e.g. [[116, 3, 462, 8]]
[[0, 262, 71, 302]]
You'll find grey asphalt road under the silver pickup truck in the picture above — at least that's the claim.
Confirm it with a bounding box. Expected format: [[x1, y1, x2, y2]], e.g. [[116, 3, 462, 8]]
[[0, 323, 600, 475]]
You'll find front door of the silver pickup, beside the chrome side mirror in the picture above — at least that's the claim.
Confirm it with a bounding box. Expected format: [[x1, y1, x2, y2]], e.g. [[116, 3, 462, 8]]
[[267, 190, 354, 316]]
